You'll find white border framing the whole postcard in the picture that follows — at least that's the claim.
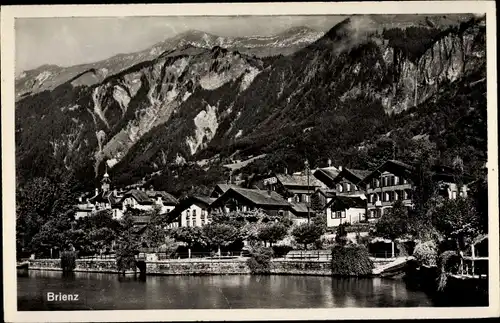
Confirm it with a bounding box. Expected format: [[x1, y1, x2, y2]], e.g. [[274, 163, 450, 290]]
[[0, 1, 500, 322]]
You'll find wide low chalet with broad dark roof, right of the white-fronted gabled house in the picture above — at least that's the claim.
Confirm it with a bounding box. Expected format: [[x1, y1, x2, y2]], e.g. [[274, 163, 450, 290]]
[[211, 187, 291, 216]]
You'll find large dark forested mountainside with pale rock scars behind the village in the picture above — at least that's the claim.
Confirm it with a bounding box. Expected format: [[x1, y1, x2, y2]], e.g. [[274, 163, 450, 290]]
[[16, 16, 486, 197]]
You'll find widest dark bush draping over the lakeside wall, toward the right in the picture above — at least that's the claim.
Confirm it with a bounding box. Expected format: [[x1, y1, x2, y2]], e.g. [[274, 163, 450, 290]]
[[332, 245, 373, 276]]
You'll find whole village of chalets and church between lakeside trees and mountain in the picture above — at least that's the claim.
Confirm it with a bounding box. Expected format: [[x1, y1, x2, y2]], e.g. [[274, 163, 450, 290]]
[[75, 160, 480, 258]]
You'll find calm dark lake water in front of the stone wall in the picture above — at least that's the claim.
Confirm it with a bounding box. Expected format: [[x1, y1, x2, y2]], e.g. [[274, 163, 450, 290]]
[[17, 271, 433, 311]]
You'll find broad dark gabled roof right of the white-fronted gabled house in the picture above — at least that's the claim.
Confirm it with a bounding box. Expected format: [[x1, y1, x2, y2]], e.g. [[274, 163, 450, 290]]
[[212, 187, 290, 208]]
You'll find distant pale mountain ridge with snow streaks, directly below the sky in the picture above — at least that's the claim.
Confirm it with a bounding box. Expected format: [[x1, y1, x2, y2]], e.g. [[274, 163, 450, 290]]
[[16, 27, 324, 98]]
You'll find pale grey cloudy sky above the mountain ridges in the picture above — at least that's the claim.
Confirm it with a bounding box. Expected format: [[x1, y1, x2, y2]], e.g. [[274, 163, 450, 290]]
[[15, 16, 345, 74]]
